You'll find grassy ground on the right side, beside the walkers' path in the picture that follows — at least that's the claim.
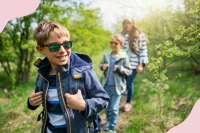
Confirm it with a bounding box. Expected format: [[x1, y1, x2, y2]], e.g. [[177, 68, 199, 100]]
[[125, 66, 200, 133]]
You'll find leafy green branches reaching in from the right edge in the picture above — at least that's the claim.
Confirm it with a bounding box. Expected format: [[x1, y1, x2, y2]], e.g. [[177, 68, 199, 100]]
[[149, 2, 200, 77]]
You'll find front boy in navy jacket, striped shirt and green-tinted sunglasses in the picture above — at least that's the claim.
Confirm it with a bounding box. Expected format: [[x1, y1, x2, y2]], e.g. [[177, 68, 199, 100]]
[[28, 20, 109, 133]]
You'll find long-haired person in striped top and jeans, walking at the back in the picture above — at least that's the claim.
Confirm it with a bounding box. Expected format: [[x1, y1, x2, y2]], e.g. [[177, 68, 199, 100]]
[[122, 19, 149, 112]]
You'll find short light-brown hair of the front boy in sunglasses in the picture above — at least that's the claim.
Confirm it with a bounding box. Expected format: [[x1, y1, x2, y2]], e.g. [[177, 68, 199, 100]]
[[34, 19, 70, 46]]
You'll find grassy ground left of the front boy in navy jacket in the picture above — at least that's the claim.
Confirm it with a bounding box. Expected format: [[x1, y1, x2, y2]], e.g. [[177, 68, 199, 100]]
[[0, 71, 41, 133]]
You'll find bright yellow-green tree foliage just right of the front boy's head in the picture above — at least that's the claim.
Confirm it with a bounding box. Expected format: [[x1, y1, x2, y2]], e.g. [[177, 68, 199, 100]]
[[67, 5, 111, 56]]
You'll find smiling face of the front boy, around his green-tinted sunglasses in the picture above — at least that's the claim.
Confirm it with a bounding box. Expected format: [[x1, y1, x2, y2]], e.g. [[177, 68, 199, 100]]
[[36, 32, 71, 70]]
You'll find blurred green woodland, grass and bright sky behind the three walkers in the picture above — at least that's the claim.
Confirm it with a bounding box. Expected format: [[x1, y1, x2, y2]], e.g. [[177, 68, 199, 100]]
[[0, 0, 200, 133]]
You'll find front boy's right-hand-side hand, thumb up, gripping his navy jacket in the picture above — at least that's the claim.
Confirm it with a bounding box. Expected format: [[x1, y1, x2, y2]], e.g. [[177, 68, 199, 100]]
[[65, 89, 85, 111]]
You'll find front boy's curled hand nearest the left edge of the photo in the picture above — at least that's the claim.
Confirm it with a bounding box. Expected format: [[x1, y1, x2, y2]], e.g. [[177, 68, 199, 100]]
[[28, 91, 43, 106]]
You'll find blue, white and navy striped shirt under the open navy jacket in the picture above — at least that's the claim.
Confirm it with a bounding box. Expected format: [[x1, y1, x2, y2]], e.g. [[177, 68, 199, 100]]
[[47, 75, 66, 133]]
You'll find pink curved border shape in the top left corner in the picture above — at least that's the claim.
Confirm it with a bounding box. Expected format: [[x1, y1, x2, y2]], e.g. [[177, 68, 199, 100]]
[[0, 0, 40, 33]]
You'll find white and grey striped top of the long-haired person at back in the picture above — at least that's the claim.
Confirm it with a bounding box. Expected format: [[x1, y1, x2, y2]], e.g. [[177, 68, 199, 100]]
[[122, 33, 149, 69]]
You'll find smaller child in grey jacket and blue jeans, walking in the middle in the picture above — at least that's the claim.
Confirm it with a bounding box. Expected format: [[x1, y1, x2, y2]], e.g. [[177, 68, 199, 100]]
[[100, 34, 132, 133]]
